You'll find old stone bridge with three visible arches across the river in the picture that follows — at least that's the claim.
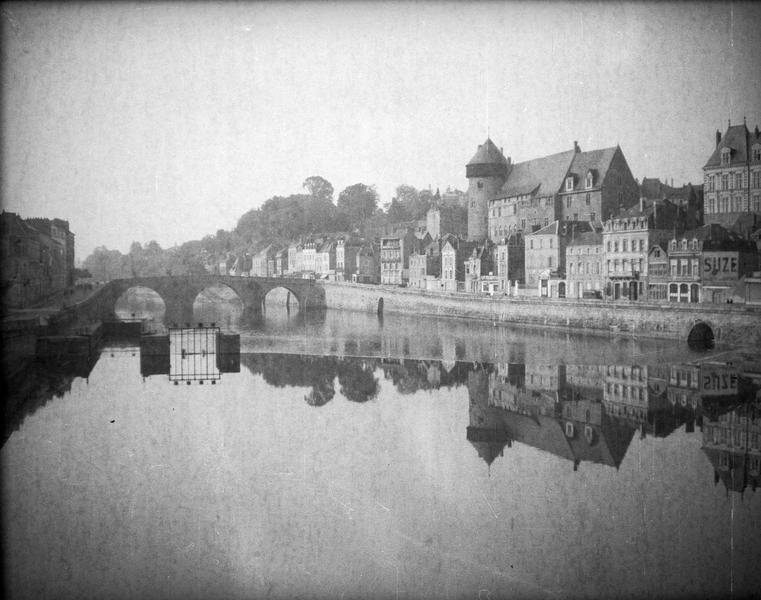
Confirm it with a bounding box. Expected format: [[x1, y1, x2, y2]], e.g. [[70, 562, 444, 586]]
[[53, 275, 326, 327]]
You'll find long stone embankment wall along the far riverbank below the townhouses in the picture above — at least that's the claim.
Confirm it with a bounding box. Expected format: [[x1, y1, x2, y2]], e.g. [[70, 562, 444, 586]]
[[319, 281, 761, 348]]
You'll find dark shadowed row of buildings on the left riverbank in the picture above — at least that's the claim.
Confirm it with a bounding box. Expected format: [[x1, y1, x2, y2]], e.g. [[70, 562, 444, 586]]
[[0, 211, 74, 308]]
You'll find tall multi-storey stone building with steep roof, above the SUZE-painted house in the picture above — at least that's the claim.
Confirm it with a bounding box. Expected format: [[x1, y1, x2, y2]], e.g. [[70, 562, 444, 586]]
[[703, 123, 761, 234]]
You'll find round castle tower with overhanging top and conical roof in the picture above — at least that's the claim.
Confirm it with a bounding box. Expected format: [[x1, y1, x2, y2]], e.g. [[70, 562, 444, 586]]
[[465, 138, 510, 242]]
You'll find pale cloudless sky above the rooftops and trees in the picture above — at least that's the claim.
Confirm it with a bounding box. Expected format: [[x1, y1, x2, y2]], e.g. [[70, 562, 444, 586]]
[[0, 2, 761, 259]]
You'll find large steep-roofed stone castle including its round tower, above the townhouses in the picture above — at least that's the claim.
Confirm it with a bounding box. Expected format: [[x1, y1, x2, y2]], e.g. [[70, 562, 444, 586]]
[[466, 139, 639, 241]]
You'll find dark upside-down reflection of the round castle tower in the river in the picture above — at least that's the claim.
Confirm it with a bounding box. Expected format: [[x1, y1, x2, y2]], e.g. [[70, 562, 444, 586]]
[[467, 368, 510, 465]]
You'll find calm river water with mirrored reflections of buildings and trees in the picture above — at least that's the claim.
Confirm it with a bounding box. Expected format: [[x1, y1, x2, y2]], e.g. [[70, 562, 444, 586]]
[[2, 302, 761, 599]]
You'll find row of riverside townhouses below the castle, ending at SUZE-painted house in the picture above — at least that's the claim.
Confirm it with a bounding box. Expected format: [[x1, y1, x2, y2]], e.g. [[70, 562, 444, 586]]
[[392, 209, 761, 303]]
